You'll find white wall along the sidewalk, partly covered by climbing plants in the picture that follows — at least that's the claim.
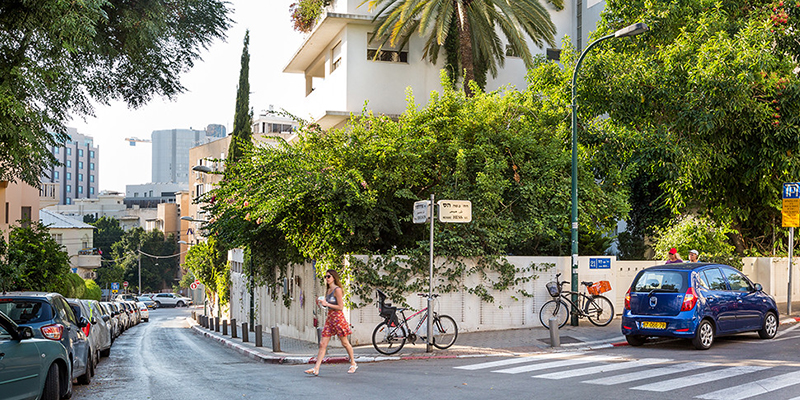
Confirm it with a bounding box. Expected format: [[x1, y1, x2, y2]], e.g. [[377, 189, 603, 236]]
[[225, 254, 800, 344]]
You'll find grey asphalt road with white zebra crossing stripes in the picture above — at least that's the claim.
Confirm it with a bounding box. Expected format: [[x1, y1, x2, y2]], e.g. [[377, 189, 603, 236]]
[[73, 309, 800, 400]]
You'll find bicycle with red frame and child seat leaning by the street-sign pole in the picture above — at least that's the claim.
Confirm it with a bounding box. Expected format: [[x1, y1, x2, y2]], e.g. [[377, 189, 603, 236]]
[[372, 290, 458, 355]]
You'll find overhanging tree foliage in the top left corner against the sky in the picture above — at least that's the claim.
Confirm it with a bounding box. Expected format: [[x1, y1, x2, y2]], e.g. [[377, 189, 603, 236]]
[[0, 0, 230, 186]]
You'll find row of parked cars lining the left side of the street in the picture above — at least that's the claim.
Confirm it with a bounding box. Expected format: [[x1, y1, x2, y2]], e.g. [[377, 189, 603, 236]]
[[0, 292, 150, 400]]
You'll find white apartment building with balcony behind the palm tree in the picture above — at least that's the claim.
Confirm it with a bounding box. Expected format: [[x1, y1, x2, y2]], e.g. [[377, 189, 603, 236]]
[[283, 0, 605, 129]]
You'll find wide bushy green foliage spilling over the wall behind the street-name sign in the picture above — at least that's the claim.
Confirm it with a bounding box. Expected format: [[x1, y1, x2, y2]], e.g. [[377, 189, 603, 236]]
[[206, 74, 627, 300]]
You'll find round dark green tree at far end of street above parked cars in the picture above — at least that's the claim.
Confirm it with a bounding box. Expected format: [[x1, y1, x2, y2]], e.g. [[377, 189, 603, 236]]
[[112, 228, 178, 292]]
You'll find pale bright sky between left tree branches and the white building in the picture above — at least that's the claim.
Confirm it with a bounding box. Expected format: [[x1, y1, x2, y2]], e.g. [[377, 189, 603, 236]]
[[67, 0, 308, 192]]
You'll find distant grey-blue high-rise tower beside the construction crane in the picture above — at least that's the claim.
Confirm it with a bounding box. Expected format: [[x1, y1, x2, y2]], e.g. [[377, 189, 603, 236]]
[[151, 124, 225, 184]]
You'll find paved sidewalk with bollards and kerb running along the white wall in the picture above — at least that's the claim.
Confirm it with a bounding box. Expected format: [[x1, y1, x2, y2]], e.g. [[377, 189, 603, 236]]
[[186, 301, 800, 364]]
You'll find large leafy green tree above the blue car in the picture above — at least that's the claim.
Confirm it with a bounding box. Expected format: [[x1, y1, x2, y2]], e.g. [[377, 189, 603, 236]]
[[579, 0, 800, 255]]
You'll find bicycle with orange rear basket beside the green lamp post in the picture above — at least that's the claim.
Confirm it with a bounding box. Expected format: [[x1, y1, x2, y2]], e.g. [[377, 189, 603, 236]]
[[539, 273, 614, 329]]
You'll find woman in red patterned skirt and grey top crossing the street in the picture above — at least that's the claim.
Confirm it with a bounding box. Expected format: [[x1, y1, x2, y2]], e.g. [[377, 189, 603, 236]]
[[305, 269, 358, 376]]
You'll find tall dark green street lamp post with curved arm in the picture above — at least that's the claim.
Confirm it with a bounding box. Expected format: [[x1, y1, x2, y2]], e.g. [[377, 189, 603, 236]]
[[570, 22, 650, 326]]
